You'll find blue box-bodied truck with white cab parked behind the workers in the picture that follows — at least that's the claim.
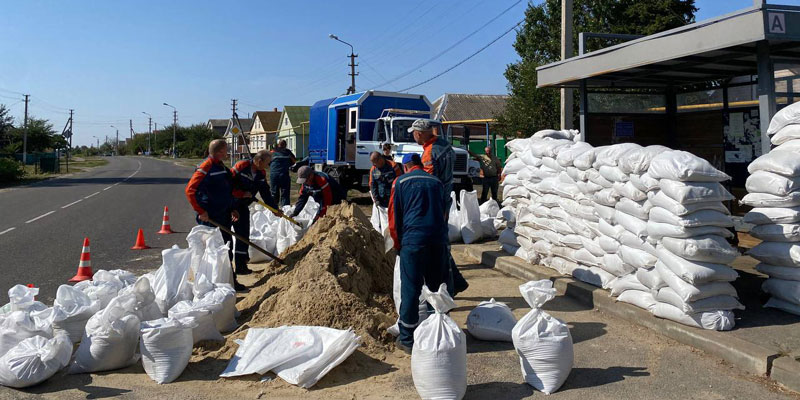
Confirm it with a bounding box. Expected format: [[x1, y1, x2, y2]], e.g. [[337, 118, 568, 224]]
[[308, 90, 478, 192]]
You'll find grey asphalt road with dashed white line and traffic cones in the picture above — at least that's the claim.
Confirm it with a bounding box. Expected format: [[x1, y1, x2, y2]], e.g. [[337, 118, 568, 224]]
[[0, 157, 195, 303]]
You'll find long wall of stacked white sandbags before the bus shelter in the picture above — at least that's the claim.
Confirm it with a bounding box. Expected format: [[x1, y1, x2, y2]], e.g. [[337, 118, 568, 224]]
[[497, 130, 742, 329]]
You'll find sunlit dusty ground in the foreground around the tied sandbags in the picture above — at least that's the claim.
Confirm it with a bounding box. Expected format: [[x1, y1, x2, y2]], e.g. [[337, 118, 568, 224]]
[[0, 245, 800, 400]]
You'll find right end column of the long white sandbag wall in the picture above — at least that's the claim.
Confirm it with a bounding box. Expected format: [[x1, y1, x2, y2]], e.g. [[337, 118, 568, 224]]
[[646, 151, 744, 330]]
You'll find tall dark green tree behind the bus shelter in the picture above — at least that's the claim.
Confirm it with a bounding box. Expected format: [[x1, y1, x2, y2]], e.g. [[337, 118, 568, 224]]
[[497, 0, 697, 136]]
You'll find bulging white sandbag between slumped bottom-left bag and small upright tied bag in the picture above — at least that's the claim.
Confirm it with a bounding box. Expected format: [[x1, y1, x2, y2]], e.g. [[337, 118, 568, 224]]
[[69, 294, 140, 374]]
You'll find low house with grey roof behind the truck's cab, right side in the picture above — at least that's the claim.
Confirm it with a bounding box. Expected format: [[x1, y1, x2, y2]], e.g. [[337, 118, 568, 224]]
[[432, 93, 508, 160]]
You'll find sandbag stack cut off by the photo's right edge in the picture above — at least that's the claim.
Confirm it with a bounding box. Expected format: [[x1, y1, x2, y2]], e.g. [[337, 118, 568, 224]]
[[742, 103, 800, 315]]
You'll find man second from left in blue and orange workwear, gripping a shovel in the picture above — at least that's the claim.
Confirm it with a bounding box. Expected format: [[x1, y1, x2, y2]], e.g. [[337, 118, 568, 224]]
[[231, 150, 281, 275]]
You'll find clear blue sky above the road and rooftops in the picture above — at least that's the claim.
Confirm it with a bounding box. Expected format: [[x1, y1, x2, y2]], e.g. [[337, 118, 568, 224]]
[[0, 0, 776, 146]]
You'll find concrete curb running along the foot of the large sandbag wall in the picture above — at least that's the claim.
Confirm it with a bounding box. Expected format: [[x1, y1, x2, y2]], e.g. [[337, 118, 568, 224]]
[[464, 244, 800, 392]]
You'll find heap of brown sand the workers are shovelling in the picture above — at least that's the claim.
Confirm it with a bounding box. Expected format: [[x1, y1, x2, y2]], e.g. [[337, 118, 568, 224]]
[[198, 204, 397, 359]]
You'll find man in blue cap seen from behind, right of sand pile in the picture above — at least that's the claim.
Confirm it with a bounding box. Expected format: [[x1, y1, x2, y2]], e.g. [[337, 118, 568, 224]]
[[389, 154, 453, 351]]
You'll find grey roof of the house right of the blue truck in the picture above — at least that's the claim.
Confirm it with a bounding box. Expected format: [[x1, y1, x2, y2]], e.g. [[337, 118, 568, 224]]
[[432, 93, 508, 121]]
